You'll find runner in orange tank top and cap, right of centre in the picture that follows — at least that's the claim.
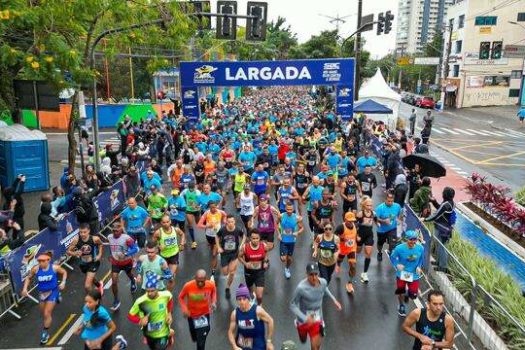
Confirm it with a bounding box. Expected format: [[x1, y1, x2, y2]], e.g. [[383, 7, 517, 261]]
[[334, 211, 357, 294]]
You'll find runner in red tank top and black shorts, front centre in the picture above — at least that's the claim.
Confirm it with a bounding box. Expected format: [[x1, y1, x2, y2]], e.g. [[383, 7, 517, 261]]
[[239, 229, 269, 305]]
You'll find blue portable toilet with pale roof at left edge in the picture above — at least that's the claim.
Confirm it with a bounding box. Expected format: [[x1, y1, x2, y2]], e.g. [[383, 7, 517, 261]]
[[0, 124, 49, 192]]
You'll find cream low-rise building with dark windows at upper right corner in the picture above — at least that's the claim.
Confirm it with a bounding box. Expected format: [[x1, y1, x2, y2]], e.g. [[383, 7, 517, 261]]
[[443, 0, 525, 108]]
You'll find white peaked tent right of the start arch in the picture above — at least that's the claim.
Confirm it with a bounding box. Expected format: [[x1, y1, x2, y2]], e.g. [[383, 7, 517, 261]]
[[355, 68, 401, 130]]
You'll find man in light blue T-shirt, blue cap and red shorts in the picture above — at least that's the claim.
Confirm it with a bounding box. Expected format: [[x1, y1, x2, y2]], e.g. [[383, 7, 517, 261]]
[[390, 230, 425, 317]]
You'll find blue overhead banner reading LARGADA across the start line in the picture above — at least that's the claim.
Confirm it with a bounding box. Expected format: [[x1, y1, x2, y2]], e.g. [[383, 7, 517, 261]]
[[180, 58, 354, 87]]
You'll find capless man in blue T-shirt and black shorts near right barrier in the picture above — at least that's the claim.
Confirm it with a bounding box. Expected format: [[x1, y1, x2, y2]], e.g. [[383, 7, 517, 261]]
[[376, 192, 403, 261]]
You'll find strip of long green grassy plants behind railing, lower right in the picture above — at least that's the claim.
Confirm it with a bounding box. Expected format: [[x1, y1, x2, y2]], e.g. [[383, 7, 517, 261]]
[[447, 232, 525, 350]]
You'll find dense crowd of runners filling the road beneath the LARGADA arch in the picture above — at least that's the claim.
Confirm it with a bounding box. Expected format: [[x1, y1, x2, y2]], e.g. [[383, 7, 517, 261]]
[[23, 88, 454, 350]]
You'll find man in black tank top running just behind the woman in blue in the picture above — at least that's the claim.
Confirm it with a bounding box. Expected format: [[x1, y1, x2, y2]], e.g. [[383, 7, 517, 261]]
[[67, 223, 104, 294]]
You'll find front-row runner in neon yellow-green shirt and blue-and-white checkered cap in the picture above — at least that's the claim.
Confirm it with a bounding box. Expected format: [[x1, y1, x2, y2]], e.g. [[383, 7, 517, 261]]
[[128, 274, 175, 350]]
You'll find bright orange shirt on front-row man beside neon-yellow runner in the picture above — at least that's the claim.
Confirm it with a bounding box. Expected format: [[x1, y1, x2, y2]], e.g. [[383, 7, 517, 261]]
[[179, 280, 217, 318]]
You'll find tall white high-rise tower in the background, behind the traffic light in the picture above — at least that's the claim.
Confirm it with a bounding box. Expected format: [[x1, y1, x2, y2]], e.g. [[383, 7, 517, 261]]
[[396, 0, 455, 53]]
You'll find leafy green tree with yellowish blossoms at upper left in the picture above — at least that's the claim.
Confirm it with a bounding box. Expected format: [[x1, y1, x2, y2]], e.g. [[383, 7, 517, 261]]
[[0, 0, 195, 170]]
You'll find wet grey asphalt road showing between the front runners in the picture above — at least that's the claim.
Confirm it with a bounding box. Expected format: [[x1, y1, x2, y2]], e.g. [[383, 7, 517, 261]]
[[0, 175, 414, 350]]
